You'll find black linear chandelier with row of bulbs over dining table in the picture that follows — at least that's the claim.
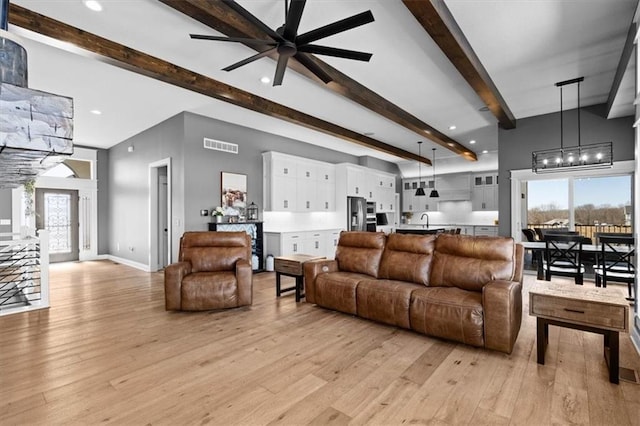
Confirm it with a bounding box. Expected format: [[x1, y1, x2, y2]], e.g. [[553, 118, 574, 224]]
[[531, 77, 613, 173]]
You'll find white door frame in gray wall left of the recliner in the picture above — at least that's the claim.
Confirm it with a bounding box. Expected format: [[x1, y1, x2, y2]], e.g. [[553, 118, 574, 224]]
[[149, 157, 173, 272]]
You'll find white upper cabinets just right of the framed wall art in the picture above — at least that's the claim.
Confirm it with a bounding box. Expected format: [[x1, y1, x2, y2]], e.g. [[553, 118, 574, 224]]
[[262, 152, 336, 212]]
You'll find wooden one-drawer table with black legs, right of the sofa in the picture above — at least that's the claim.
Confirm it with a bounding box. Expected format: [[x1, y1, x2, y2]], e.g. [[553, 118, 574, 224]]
[[529, 282, 629, 384]]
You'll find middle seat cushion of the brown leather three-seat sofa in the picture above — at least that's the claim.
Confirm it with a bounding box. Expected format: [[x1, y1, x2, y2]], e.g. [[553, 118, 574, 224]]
[[356, 279, 423, 328]]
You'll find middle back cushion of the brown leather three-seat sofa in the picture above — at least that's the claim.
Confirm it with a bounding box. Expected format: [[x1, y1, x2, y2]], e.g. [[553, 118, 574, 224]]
[[378, 234, 436, 285]]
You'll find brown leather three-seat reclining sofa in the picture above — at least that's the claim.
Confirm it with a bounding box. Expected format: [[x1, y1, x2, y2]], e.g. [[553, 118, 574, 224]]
[[305, 232, 524, 353]]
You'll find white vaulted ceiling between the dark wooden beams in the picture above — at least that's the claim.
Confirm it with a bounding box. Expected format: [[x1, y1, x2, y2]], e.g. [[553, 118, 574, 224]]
[[3, 0, 636, 176]]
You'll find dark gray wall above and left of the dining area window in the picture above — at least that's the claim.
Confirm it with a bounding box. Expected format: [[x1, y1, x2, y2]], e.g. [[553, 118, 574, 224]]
[[498, 104, 634, 236]]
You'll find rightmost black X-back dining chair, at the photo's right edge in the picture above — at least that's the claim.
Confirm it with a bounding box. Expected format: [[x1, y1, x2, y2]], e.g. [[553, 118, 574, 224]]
[[594, 234, 636, 301]]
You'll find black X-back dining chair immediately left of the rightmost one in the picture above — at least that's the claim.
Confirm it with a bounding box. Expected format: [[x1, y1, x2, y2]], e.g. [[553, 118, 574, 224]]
[[542, 233, 584, 285]]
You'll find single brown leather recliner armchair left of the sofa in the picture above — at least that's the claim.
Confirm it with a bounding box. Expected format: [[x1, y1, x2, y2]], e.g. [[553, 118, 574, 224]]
[[164, 232, 253, 311]]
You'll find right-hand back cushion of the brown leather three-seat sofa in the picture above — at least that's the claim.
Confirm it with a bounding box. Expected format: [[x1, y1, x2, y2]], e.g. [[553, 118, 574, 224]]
[[429, 234, 515, 291]]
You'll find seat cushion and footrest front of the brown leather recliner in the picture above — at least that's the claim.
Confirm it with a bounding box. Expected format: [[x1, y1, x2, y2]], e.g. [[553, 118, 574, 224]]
[[180, 271, 238, 311]]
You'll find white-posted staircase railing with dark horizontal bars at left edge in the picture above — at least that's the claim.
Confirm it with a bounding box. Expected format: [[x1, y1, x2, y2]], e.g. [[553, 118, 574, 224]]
[[0, 230, 49, 315]]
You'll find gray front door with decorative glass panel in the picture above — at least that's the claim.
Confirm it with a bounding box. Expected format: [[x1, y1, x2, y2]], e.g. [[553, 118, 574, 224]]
[[35, 188, 79, 263]]
